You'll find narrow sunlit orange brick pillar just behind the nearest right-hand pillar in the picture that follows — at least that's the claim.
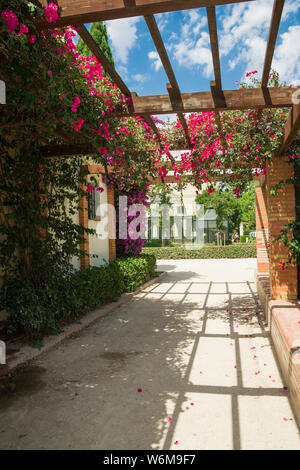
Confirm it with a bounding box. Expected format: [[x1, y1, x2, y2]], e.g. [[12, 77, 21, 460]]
[[255, 186, 269, 274]]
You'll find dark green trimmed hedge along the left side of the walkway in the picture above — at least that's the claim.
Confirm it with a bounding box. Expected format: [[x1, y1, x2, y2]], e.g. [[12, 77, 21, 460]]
[[1, 254, 156, 339]]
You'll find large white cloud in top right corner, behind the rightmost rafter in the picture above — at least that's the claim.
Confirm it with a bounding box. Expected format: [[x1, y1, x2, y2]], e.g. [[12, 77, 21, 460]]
[[219, 0, 300, 83]]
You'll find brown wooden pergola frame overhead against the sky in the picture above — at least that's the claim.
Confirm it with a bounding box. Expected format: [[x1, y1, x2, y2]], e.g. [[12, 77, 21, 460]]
[[35, 0, 300, 155]]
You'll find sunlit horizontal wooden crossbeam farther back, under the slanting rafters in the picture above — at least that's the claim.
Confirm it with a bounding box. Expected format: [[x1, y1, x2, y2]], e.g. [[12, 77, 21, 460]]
[[124, 87, 300, 115]]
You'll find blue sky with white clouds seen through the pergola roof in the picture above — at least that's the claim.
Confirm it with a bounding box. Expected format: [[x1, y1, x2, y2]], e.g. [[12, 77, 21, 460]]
[[78, 0, 300, 121]]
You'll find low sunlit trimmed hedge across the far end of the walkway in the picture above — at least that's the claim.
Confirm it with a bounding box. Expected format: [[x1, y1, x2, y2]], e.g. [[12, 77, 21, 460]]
[[143, 243, 256, 259]]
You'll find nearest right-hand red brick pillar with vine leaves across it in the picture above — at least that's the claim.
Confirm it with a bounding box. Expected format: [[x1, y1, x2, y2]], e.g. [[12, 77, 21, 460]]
[[267, 156, 297, 300]]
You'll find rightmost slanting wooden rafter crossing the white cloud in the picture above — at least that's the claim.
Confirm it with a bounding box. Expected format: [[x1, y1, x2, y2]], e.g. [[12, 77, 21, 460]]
[[261, 0, 284, 87]]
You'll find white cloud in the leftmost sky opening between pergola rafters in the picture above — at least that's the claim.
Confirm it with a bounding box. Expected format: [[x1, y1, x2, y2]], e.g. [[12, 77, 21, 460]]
[[106, 18, 140, 64]]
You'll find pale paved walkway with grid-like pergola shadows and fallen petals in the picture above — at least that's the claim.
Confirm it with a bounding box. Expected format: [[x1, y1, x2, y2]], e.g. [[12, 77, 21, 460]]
[[0, 260, 300, 450]]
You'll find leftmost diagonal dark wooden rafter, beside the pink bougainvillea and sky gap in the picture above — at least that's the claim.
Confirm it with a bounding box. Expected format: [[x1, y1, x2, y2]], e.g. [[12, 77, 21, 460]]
[[77, 25, 131, 97]]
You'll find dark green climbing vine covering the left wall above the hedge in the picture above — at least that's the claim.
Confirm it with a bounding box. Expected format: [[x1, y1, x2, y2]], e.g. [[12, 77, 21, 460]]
[[0, 0, 158, 300]]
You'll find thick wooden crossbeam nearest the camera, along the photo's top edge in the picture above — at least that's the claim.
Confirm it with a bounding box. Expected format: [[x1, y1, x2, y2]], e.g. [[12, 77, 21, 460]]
[[38, 0, 253, 29]]
